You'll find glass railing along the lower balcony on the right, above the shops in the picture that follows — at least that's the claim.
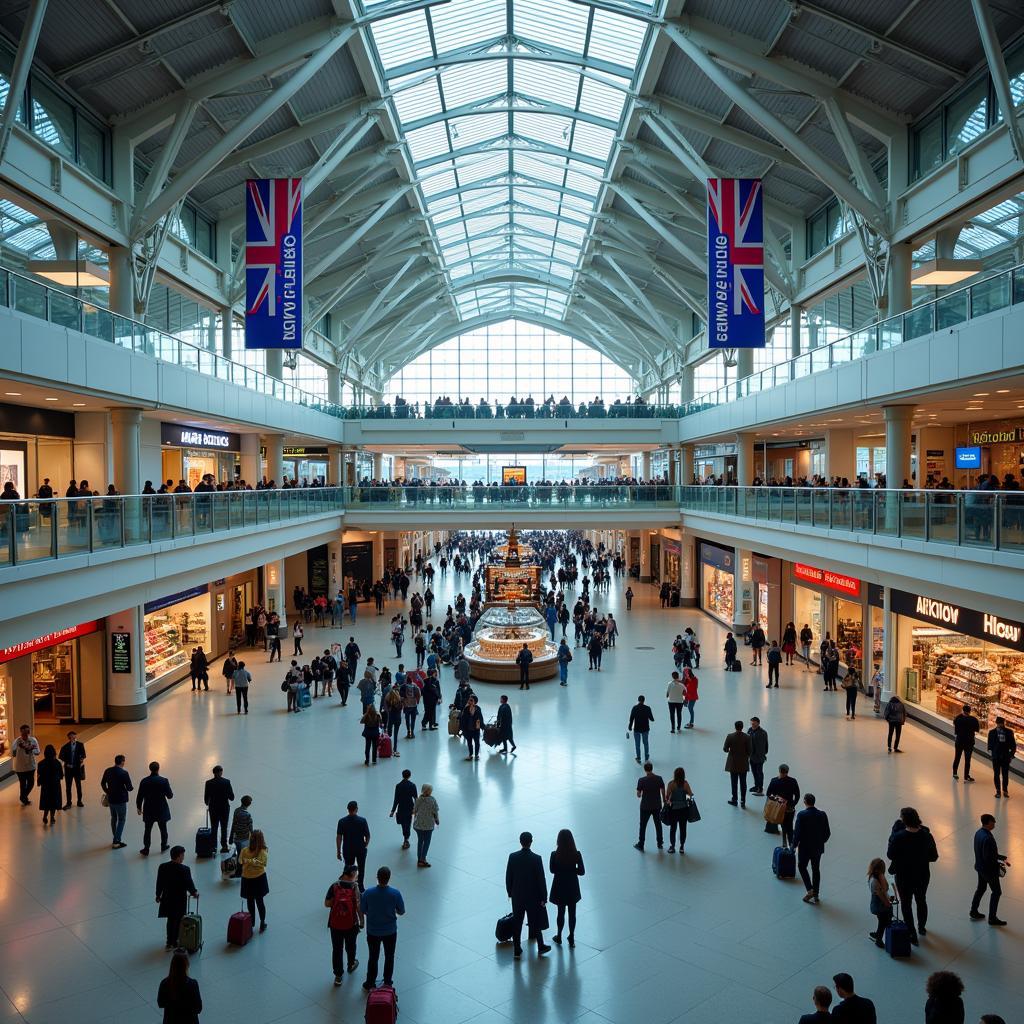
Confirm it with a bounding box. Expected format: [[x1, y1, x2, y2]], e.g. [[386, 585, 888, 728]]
[[681, 486, 1024, 552]]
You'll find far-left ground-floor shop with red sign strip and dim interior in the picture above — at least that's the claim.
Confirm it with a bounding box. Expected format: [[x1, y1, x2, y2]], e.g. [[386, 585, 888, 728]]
[[0, 621, 105, 777]]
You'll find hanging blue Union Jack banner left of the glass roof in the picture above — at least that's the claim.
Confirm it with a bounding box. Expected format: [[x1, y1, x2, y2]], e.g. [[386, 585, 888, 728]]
[[246, 178, 302, 348]]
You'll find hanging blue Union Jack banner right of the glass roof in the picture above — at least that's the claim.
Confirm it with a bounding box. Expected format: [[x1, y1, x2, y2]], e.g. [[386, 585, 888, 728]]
[[708, 178, 765, 348]]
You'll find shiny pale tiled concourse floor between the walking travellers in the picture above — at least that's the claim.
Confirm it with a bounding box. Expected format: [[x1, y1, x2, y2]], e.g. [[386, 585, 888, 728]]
[[0, 574, 1024, 1024]]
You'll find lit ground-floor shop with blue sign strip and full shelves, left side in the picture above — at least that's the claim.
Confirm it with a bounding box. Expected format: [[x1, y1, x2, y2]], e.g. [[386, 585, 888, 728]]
[[142, 584, 209, 695]]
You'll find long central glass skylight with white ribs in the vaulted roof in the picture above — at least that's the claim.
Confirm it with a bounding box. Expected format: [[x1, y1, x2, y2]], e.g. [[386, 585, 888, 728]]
[[364, 0, 660, 319]]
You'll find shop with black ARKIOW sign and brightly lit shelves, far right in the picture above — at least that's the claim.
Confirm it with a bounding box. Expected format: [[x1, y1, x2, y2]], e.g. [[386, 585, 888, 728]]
[[890, 590, 1024, 733]]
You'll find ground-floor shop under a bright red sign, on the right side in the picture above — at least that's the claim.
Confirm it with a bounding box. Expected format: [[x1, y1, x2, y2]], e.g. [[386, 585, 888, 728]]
[[791, 562, 864, 675]]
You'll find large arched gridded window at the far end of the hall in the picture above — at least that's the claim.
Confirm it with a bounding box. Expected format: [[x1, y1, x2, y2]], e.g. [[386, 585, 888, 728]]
[[384, 319, 636, 404]]
